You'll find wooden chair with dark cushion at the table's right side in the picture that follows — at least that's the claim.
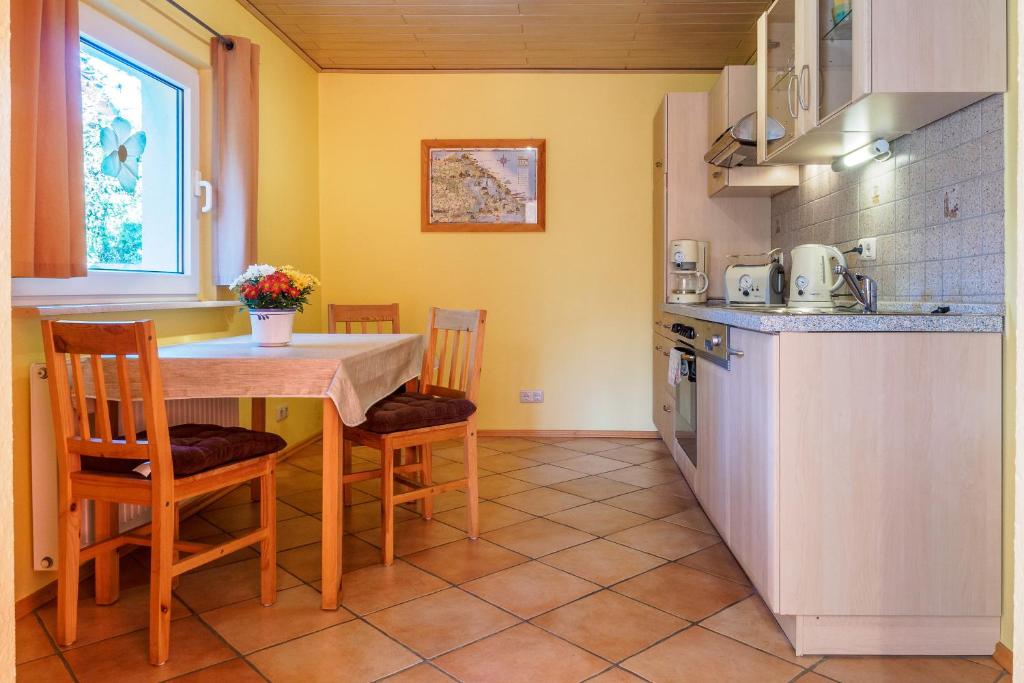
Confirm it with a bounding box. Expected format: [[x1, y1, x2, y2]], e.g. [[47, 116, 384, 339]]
[[344, 308, 487, 564]]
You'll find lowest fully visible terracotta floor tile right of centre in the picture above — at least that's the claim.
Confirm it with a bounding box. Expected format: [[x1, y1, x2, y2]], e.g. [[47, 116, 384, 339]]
[[532, 591, 689, 661]]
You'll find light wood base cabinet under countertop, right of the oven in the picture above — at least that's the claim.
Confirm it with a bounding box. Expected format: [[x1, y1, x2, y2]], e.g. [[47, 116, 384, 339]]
[[684, 328, 1001, 654]]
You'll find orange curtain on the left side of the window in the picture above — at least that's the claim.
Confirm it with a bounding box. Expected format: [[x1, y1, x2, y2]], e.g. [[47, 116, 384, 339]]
[[10, 0, 86, 278]]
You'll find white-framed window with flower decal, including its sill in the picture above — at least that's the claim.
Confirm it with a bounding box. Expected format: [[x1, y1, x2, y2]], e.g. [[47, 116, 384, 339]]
[[14, 6, 199, 303]]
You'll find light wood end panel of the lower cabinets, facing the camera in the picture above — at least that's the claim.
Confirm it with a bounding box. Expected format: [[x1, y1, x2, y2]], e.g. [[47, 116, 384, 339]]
[[779, 333, 1001, 616]]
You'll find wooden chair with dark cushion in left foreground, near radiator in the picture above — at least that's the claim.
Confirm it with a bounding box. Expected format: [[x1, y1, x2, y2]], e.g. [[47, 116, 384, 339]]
[[43, 321, 284, 665]]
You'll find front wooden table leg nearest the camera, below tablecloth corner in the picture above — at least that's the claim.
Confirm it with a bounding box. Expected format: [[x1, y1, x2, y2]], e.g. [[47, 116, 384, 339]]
[[321, 398, 344, 609]]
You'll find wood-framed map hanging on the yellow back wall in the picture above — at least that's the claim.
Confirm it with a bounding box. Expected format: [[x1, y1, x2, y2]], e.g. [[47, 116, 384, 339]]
[[420, 139, 545, 232]]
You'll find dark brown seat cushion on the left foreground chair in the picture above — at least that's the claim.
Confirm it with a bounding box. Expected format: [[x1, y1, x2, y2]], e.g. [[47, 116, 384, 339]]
[[82, 424, 287, 477]]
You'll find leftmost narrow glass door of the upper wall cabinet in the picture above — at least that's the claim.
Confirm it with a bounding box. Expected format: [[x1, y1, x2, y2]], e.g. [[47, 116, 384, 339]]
[[765, 0, 800, 155]]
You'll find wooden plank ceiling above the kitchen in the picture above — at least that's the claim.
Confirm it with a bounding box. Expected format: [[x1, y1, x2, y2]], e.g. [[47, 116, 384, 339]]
[[243, 0, 770, 71]]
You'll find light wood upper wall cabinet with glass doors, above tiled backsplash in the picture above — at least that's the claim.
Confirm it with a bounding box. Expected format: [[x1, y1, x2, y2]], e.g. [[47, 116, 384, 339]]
[[757, 0, 1007, 164]]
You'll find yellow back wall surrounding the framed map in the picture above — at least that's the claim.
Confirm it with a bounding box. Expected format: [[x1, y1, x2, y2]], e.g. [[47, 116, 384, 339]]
[[319, 74, 713, 430]]
